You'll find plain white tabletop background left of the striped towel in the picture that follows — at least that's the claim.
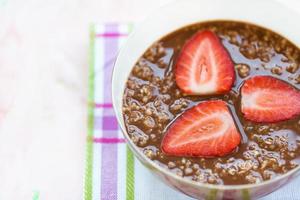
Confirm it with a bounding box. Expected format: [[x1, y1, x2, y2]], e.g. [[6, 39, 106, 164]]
[[0, 0, 300, 200]]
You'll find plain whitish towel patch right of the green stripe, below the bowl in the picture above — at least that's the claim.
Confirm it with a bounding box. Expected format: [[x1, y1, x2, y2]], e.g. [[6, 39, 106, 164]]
[[134, 158, 193, 200]]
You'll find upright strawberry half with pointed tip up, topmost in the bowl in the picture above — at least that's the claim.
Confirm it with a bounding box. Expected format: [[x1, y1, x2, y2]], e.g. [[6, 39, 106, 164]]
[[175, 30, 235, 95]]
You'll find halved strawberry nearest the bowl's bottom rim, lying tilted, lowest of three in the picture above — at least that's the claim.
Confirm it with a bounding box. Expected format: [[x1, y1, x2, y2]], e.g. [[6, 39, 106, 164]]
[[162, 100, 241, 157]]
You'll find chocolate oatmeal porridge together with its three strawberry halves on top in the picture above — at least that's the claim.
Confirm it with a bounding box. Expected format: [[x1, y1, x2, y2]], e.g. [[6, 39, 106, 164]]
[[123, 21, 300, 185]]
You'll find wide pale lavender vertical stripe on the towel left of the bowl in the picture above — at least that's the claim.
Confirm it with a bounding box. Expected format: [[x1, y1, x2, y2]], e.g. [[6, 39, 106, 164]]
[[101, 25, 118, 200]]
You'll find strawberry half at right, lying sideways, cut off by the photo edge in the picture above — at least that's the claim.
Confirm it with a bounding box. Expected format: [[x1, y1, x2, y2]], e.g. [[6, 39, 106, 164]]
[[241, 76, 300, 122]]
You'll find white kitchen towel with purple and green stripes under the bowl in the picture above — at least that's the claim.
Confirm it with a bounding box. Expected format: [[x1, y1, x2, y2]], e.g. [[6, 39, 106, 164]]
[[84, 24, 300, 200]]
